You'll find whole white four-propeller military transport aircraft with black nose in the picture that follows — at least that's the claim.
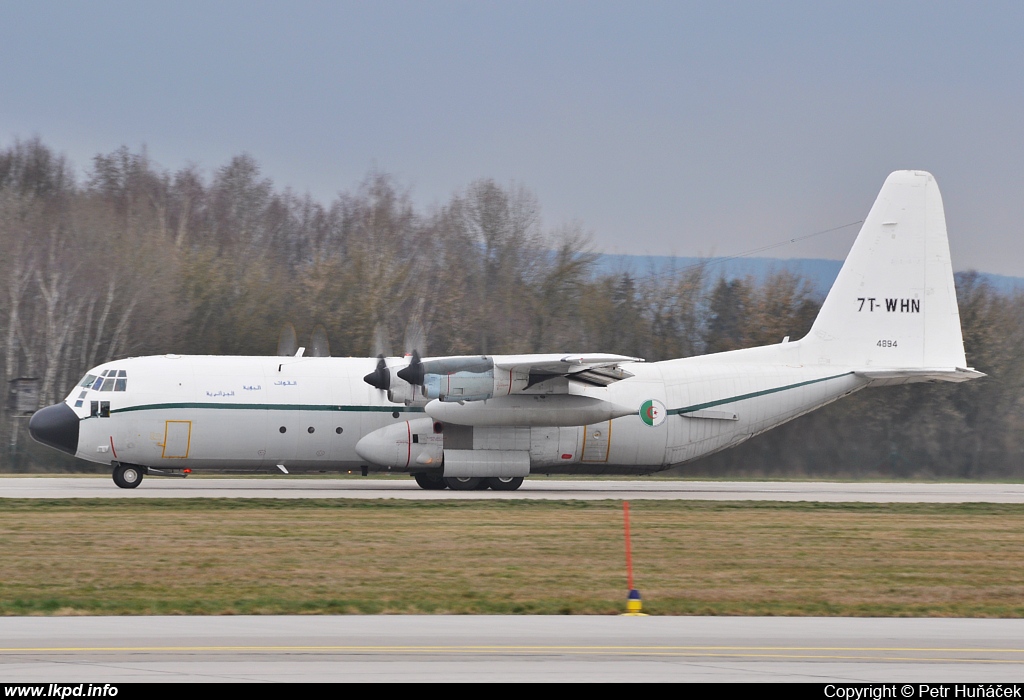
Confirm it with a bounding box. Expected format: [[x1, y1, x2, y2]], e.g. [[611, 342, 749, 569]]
[[29, 171, 983, 490]]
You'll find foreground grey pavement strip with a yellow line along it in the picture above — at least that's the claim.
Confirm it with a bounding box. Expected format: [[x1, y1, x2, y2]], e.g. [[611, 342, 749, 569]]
[[0, 615, 1024, 684]]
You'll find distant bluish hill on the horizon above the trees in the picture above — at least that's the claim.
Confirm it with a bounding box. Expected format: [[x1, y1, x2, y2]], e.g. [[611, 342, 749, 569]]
[[597, 255, 1024, 297]]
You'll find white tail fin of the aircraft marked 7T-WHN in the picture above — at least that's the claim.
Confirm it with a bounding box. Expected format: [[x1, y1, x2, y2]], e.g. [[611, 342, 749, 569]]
[[803, 170, 981, 381]]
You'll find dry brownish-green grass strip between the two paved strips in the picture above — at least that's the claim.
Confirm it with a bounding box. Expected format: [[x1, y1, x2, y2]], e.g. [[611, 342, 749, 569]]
[[0, 498, 1024, 617]]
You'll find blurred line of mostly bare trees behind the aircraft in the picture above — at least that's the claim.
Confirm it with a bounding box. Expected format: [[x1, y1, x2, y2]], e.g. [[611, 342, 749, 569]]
[[0, 138, 1024, 478]]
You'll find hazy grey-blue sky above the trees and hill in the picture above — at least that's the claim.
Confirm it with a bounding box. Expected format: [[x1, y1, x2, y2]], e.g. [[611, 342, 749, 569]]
[[0, 0, 1024, 276]]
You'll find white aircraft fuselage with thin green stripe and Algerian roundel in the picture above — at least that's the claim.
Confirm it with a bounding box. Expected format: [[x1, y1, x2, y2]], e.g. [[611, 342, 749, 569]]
[[46, 343, 867, 473]]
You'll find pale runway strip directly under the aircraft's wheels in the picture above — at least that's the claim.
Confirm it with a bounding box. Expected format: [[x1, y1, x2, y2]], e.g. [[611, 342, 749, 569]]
[[0, 476, 1024, 504]]
